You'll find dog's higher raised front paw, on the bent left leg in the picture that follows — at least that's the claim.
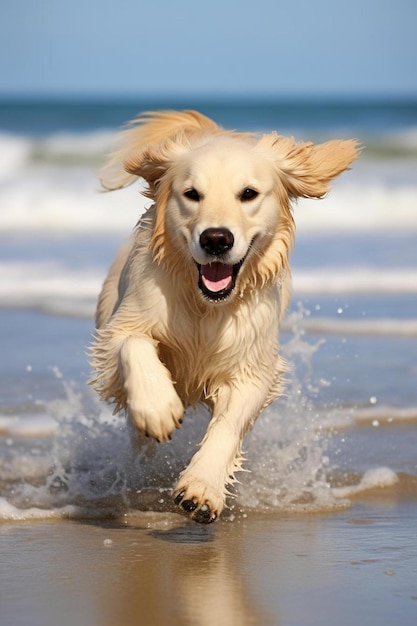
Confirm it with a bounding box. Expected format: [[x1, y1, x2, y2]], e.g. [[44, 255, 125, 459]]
[[128, 385, 184, 442]]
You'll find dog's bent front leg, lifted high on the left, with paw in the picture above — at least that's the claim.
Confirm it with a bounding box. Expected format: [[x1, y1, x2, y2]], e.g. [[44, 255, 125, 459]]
[[120, 335, 184, 441]]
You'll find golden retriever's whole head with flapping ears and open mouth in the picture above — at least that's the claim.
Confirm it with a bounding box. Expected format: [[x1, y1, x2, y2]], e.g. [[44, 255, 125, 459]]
[[101, 112, 357, 304]]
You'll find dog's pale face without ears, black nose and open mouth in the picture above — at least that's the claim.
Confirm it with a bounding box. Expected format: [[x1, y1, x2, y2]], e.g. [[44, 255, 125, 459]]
[[166, 138, 280, 304]]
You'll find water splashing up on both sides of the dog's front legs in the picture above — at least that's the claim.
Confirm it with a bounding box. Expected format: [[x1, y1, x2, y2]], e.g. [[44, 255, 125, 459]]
[[0, 307, 348, 517]]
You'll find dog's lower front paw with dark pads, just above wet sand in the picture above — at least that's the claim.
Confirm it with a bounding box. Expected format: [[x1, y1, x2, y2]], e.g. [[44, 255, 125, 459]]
[[174, 479, 224, 524]]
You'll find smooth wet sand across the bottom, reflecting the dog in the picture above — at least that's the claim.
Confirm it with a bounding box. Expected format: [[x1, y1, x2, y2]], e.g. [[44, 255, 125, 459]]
[[0, 492, 417, 626]]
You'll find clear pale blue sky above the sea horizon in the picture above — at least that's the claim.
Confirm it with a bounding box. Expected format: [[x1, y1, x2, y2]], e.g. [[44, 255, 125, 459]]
[[0, 0, 417, 97]]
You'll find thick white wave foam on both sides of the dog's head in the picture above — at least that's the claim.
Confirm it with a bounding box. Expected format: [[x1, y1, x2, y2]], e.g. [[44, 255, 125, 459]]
[[0, 179, 417, 234]]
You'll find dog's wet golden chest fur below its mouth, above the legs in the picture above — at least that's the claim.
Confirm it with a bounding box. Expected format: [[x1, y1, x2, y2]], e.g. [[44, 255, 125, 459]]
[[155, 294, 278, 403]]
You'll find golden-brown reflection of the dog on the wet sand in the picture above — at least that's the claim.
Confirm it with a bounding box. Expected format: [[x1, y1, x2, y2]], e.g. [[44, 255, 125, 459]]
[[98, 522, 276, 626]]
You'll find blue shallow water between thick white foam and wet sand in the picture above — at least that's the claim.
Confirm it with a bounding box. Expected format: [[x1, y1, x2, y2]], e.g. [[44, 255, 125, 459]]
[[0, 212, 417, 519]]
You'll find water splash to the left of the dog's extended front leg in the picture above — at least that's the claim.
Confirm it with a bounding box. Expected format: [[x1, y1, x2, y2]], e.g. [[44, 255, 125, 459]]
[[0, 369, 208, 519]]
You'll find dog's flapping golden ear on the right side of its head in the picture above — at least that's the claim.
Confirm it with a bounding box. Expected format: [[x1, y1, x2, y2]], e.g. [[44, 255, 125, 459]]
[[258, 133, 360, 198]]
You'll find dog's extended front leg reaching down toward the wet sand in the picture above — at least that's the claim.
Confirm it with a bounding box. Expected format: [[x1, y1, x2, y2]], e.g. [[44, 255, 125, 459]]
[[174, 385, 268, 524]]
